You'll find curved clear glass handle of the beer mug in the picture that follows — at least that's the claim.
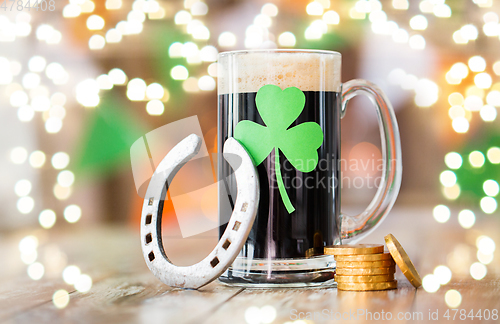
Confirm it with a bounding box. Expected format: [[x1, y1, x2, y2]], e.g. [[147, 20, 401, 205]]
[[337, 79, 403, 243]]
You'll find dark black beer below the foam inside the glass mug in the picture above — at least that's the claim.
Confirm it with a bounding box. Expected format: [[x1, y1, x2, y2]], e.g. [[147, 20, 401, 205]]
[[218, 91, 341, 260]]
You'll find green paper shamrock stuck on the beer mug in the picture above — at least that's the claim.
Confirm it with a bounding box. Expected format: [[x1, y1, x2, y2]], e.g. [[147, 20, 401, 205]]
[[234, 84, 323, 213]]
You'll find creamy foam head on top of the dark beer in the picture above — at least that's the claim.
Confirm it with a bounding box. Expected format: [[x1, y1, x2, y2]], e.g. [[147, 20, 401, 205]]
[[218, 51, 341, 94]]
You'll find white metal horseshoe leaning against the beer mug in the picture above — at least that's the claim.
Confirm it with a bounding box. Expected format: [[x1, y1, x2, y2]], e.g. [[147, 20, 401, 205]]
[[141, 134, 259, 289]]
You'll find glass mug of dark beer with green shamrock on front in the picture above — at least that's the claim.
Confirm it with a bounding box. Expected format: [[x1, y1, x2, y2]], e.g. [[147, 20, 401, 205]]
[[218, 50, 402, 287]]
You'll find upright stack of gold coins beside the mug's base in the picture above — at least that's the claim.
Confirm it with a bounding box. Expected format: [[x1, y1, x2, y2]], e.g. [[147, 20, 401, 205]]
[[324, 244, 397, 291]]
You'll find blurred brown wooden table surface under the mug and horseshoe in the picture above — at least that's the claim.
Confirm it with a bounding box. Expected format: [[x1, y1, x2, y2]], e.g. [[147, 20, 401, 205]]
[[0, 207, 500, 324]]
